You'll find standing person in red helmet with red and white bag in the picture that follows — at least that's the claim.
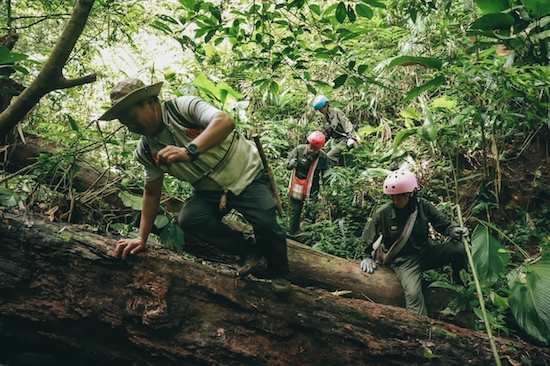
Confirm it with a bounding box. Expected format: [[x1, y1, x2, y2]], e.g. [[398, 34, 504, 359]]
[[286, 131, 329, 237]]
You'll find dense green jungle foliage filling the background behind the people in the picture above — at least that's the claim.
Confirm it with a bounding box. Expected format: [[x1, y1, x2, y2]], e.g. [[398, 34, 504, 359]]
[[0, 0, 550, 343]]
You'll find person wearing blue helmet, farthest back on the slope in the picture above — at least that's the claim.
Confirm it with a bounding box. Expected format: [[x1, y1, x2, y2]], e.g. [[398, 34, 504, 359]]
[[312, 95, 359, 166]]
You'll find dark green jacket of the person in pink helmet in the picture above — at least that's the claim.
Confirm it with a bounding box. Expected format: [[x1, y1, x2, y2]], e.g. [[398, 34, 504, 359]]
[[361, 198, 458, 258]]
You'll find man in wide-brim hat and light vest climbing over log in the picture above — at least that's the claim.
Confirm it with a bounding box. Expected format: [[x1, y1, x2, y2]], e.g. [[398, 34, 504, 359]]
[[99, 78, 296, 292]]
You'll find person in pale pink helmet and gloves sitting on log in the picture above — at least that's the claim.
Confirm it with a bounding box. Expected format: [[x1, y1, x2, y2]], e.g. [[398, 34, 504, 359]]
[[360, 169, 469, 315]]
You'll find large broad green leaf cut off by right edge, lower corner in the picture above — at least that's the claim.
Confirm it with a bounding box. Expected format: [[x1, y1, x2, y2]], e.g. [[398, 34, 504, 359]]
[[508, 254, 550, 343]]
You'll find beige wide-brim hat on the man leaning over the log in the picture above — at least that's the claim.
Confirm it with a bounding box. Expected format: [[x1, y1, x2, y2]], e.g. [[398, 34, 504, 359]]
[[99, 78, 163, 121]]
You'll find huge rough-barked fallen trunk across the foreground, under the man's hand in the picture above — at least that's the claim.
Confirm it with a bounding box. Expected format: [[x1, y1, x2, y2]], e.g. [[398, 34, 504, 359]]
[[0, 214, 550, 366]]
